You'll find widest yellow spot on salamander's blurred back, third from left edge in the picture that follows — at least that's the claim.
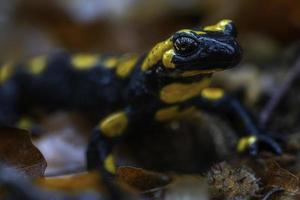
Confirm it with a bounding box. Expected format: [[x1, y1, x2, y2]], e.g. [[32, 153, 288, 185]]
[[71, 54, 99, 70]]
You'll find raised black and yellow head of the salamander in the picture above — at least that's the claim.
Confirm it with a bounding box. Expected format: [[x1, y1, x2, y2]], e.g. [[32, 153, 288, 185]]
[[142, 20, 242, 79]]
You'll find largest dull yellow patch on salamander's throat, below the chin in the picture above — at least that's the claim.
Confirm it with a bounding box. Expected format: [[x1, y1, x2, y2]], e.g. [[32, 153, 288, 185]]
[[160, 78, 210, 103]]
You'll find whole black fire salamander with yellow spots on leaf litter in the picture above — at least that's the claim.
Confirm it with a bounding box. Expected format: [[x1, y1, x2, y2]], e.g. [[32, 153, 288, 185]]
[[0, 20, 282, 173]]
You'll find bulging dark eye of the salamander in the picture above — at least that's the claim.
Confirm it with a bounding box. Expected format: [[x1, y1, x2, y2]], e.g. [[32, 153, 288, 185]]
[[174, 37, 198, 55]]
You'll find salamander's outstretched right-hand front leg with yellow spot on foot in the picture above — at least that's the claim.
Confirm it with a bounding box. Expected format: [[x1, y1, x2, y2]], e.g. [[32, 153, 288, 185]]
[[193, 88, 282, 156]]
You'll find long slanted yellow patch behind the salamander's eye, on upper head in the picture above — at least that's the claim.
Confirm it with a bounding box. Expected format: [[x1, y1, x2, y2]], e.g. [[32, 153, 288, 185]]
[[142, 38, 173, 71]]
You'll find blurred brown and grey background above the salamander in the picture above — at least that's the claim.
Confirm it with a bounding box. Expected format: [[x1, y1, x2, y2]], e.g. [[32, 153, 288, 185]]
[[0, 0, 300, 60]]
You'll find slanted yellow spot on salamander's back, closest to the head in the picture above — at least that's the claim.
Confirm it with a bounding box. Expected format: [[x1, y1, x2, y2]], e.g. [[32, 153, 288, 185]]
[[116, 55, 138, 78]]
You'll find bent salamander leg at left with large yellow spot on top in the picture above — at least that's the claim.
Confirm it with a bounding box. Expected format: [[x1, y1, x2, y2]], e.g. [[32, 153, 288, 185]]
[[87, 109, 132, 174]]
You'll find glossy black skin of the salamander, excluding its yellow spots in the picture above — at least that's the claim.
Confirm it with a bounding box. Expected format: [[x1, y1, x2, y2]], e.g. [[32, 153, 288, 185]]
[[0, 23, 282, 176]]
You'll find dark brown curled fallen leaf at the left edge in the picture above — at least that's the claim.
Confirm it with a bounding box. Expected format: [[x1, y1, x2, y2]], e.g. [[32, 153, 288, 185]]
[[0, 127, 47, 177]]
